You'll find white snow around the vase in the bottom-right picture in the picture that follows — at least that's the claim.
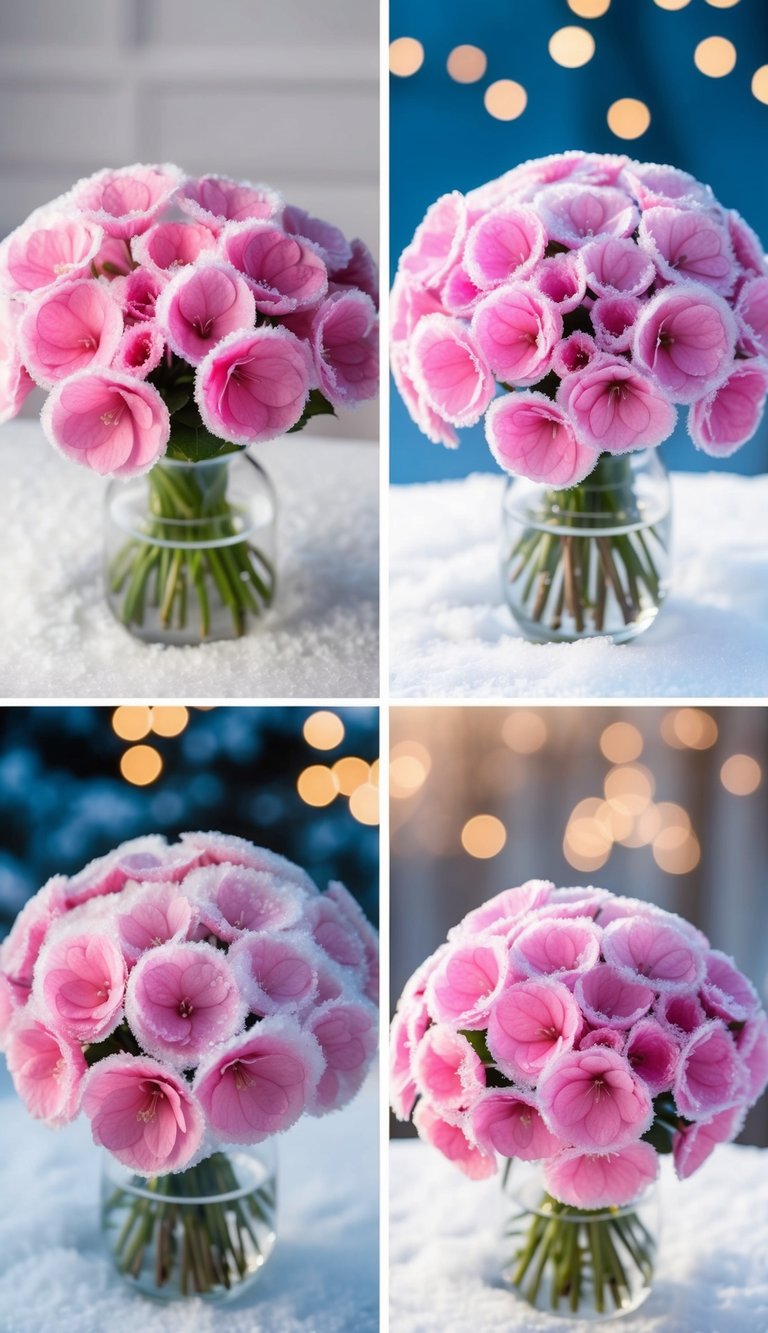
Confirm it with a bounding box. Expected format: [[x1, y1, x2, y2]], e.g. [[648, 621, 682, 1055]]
[[389, 1141, 768, 1333]]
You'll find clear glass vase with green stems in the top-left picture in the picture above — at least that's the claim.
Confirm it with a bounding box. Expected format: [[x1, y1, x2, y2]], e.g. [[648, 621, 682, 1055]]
[[104, 451, 276, 644]]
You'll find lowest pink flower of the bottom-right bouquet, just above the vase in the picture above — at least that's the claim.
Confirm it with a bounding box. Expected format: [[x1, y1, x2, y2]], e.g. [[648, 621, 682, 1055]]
[[544, 1144, 659, 1208]]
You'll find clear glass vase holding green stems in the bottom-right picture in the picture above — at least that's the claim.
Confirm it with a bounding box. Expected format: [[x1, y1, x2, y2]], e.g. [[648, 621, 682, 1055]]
[[504, 1162, 660, 1322]]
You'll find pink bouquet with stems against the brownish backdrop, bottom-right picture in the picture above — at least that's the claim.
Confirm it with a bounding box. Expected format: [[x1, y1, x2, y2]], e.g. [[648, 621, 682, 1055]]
[[391, 880, 768, 1312]]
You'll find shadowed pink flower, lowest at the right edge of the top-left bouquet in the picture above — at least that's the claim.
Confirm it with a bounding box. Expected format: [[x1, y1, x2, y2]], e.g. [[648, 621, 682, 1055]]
[[312, 291, 379, 407]]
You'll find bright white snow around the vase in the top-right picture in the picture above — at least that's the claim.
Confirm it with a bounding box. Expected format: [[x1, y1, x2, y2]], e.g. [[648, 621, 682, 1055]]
[[389, 472, 768, 698]]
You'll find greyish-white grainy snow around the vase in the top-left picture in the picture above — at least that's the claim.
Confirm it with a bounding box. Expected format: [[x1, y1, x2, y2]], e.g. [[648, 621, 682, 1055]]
[[0, 421, 379, 698]]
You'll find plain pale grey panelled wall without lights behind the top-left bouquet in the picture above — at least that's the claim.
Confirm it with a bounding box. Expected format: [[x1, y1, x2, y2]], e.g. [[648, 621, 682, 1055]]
[[0, 0, 379, 440]]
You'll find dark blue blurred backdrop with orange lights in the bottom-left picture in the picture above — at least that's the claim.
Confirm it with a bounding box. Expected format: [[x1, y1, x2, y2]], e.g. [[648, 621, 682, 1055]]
[[0, 706, 379, 937]]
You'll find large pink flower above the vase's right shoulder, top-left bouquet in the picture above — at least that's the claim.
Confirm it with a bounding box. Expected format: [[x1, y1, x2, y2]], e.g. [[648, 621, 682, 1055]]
[[195, 328, 309, 444]]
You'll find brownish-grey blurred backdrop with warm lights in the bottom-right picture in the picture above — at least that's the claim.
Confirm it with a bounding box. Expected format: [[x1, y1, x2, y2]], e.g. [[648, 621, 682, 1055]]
[[389, 706, 768, 1146]]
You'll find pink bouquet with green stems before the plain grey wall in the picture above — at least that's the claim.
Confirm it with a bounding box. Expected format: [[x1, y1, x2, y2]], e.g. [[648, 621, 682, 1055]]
[[0, 165, 379, 637]]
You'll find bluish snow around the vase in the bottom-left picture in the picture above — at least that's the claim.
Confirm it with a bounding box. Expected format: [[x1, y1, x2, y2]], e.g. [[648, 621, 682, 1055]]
[[0, 1058, 379, 1333]]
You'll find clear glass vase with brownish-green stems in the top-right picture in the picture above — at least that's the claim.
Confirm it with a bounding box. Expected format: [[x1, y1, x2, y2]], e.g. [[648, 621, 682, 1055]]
[[501, 449, 672, 644]]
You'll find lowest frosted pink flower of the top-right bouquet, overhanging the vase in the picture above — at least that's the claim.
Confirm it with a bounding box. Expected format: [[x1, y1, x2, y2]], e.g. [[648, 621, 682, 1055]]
[[485, 392, 599, 487]]
